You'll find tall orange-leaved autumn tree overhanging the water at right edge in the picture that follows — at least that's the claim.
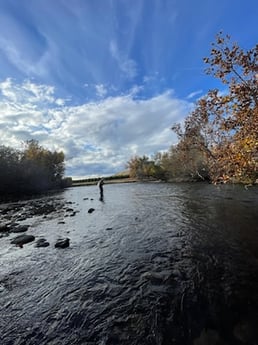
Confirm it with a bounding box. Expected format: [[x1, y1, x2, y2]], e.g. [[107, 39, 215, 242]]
[[172, 33, 258, 182]]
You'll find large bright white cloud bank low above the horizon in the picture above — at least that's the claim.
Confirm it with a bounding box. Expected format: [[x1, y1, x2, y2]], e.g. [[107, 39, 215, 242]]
[[0, 79, 191, 176]]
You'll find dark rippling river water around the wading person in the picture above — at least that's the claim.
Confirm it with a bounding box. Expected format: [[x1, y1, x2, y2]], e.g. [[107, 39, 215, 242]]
[[0, 183, 258, 345]]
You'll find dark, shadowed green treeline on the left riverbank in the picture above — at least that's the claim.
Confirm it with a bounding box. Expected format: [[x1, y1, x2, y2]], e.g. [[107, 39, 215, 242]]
[[0, 140, 71, 197]]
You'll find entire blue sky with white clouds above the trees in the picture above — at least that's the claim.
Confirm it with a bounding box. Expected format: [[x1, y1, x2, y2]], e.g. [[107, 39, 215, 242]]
[[0, 0, 258, 179]]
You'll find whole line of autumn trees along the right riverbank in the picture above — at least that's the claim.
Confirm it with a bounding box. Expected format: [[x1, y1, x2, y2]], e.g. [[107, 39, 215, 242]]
[[128, 33, 258, 183]]
